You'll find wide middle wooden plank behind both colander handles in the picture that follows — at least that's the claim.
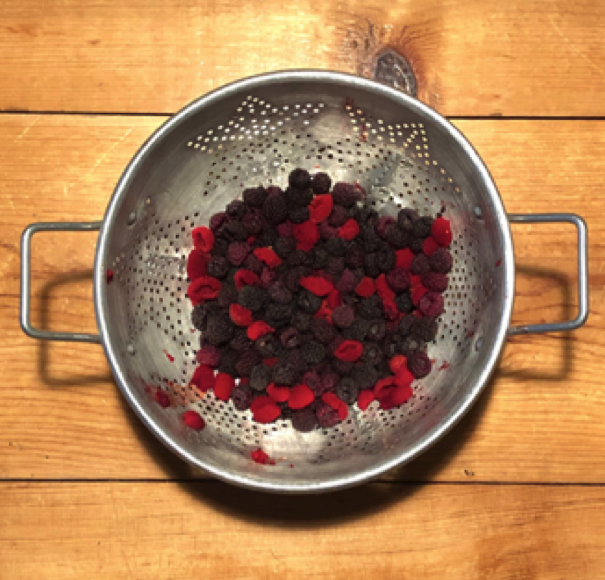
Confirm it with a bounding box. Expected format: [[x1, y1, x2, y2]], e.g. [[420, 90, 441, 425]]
[[0, 115, 605, 482]]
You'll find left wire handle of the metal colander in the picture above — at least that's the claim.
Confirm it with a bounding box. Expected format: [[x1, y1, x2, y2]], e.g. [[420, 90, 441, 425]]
[[21, 222, 102, 343]]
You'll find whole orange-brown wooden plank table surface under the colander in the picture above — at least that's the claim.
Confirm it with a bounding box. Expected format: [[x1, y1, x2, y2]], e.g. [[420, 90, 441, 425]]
[[0, 0, 605, 580]]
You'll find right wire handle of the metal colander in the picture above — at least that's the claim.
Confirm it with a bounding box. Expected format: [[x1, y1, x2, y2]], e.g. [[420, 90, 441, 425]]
[[508, 213, 588, 336]]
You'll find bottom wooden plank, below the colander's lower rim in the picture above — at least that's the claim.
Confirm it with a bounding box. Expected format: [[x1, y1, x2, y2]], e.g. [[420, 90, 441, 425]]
[[0, 482, 605, 580]]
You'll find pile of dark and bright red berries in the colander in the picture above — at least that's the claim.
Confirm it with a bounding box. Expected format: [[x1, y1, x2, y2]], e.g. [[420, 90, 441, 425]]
[[182, 169, 452, 432]]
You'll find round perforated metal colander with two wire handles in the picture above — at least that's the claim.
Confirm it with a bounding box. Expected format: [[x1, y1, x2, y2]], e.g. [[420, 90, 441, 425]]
[[22, 71, 587, 492]]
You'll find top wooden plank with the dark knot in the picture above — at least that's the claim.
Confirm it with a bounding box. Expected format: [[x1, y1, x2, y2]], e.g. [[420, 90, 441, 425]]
[[0, 0, 605, 116]]
